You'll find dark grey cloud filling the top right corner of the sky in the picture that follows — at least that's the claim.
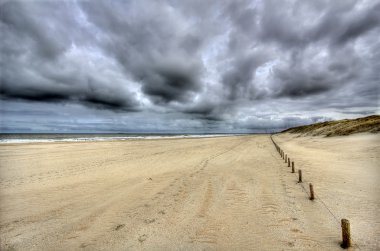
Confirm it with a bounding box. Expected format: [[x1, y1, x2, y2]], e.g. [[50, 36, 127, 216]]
[[257, 1, 380, 49]]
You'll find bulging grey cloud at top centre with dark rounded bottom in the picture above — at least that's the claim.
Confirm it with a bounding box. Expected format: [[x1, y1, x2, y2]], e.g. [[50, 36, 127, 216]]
[[78, 2, 208, 104]]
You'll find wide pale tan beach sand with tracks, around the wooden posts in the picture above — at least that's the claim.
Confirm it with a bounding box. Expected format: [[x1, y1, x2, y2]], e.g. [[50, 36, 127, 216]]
[[0, 134, 380, 250]]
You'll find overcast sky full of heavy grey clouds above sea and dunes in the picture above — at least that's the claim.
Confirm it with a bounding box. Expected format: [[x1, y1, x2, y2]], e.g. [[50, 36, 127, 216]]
[[0, 0, 380, 133]]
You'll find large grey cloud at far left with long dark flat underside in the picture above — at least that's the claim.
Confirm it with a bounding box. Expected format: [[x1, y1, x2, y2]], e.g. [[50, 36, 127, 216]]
[[0, 1, 138, 111]]
